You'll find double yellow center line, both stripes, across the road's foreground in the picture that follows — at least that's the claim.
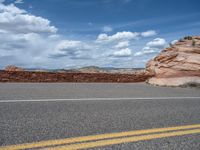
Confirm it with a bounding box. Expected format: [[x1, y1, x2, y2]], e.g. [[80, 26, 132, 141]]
[[0, 124, 200, 150]]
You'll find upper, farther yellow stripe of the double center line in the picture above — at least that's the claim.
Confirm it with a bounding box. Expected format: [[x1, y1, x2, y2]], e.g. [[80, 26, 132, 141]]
[[0, 124, 200, 150]]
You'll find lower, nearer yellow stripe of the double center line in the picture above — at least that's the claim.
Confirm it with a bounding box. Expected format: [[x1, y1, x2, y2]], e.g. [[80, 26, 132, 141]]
[[51, 129, 200, 150]]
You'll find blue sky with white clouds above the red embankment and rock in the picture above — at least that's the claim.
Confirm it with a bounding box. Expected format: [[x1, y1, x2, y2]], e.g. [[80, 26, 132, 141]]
[[0, 0, 200, 69]]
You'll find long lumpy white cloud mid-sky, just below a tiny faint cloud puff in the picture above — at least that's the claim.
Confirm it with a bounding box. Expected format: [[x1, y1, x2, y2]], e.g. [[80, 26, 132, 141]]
[[96, 31, 139, 43]]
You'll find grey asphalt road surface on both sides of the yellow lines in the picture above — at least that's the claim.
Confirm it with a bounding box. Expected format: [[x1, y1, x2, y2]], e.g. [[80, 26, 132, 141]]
[[0, 83, 200, 150]]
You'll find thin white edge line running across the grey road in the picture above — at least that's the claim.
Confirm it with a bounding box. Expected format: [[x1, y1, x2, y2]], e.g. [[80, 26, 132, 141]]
[[0, 97, 200, 103]]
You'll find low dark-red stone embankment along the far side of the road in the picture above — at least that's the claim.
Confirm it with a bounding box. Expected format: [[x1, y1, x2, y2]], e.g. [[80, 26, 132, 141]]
[[0, 70, 150, 83]]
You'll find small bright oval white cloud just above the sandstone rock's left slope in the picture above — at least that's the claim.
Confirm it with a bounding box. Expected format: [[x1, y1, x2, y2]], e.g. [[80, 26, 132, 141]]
[[147, 38, 167, 48]]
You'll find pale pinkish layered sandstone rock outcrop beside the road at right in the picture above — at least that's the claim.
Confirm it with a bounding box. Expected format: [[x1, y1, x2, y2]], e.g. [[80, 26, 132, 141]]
[[146, 36, 200, 86]]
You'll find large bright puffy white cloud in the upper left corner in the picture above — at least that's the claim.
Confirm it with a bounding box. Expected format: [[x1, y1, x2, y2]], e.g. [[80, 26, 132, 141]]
[[0, 4, 57, 33]]
